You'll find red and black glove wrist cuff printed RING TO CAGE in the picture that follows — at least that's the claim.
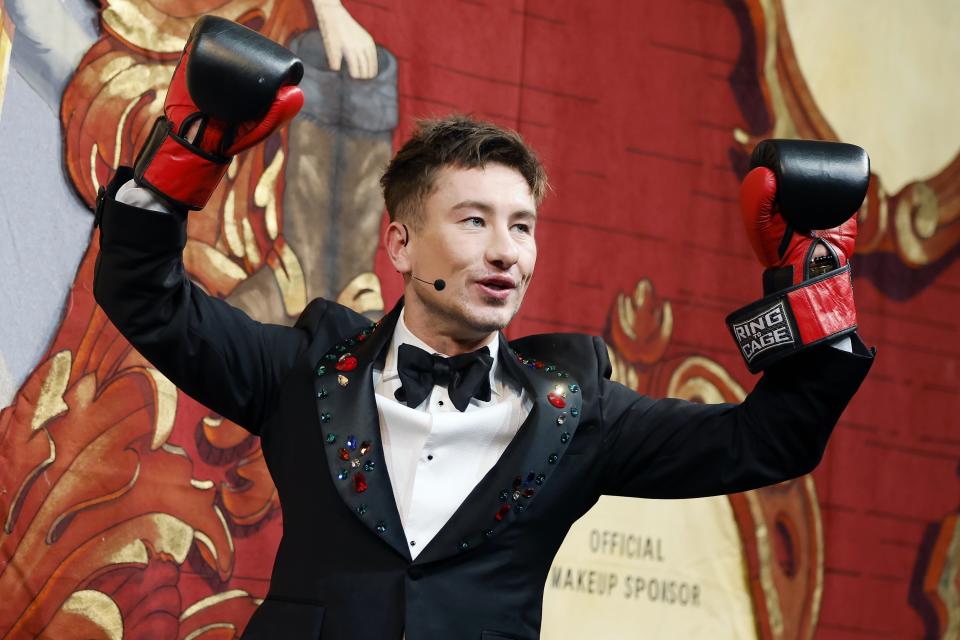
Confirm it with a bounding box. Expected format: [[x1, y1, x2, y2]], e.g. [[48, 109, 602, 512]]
[[726, 265, 857, 373]]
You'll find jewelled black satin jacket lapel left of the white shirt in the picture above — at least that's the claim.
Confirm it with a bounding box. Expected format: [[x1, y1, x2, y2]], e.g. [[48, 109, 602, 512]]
[[314, 303, 410, 560]]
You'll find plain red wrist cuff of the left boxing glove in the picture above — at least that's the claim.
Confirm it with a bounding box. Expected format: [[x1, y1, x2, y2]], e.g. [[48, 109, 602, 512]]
[[133, 117, 230, 211]]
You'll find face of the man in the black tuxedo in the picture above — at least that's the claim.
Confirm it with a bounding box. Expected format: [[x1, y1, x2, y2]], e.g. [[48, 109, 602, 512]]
[[406, 164, 537, 339]]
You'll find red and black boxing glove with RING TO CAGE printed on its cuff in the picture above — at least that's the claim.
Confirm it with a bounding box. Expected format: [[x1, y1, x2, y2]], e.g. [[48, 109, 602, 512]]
[[727, 140, 870, 373]]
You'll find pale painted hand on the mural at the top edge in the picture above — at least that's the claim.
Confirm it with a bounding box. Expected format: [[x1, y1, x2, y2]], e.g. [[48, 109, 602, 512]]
[[312, 0, 378, 80]]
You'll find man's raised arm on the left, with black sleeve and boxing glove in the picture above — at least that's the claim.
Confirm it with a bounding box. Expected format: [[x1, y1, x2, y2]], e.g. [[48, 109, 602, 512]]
[[94, 16, 312, 432]]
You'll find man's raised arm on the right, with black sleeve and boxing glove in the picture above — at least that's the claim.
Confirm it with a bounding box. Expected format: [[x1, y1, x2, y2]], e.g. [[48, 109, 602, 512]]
[[597, 140, 873, 498]]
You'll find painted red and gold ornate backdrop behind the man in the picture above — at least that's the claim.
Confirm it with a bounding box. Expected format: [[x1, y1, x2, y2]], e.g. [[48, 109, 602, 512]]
[[0, 0, 960, 639]]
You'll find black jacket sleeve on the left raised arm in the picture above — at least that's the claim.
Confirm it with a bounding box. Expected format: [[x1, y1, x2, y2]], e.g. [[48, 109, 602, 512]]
[[93, 170, 309, 433]]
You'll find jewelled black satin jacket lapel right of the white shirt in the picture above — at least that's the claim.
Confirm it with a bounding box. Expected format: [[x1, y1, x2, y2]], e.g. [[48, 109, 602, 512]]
[[416, 334, 581, 564]]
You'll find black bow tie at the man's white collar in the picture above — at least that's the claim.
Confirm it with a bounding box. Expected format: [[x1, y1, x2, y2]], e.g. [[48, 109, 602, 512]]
[[394, 344, 493, 411]]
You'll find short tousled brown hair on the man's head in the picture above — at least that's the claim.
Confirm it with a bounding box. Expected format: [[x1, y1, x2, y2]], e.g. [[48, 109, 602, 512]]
[[380, 115, 547, 227]]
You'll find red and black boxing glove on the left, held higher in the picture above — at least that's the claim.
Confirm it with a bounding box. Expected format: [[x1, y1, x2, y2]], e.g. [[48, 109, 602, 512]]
[[134, 16, 303, 210]]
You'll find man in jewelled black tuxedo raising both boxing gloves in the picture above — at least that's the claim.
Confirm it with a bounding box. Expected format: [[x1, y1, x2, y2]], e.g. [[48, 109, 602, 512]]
[[94, 18, 872, 640]]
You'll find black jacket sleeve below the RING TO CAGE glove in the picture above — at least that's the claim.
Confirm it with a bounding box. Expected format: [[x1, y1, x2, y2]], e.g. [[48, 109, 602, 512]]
[[596, 336, 874, 498]]
